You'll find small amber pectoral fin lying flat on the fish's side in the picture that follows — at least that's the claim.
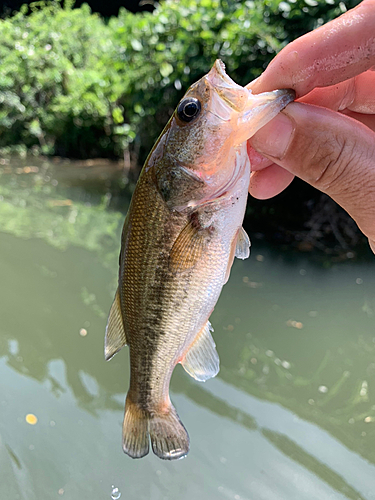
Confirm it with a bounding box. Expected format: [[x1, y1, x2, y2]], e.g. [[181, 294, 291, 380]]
[[169, 221, 210, 272]]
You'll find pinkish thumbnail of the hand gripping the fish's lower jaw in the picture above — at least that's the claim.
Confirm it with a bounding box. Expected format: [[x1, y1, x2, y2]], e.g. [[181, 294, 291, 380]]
[[250, 113, 294, 160]]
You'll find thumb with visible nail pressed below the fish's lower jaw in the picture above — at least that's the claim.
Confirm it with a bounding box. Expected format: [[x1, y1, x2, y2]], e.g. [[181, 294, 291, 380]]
[[250, 102, 375, 248]]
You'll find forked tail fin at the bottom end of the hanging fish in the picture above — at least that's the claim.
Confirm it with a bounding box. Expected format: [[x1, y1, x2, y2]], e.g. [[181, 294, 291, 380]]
[[122, 397, 189, 460]]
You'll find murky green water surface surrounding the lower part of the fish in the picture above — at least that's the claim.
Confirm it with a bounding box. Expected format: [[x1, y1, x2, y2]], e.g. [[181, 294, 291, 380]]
[[0, 157, 375, 500]]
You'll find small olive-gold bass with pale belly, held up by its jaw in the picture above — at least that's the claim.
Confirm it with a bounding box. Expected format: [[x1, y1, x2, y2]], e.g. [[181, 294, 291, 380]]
[[104, 60, 295, 460]]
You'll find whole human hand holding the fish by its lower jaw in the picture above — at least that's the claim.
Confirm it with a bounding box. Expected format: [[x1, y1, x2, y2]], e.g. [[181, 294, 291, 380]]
[[248, 0, 375, 253]]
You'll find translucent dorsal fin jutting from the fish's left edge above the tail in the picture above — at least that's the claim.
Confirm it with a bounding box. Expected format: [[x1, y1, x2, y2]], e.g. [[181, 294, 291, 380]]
[[104, 289, 127, 361]]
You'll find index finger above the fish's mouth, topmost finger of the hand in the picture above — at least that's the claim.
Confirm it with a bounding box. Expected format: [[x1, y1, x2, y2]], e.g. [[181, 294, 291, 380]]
[[247, 0, 375, 97]]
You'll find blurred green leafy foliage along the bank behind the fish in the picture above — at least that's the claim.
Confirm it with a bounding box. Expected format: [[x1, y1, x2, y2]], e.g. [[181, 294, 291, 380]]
[[0, 0, 358, 163]]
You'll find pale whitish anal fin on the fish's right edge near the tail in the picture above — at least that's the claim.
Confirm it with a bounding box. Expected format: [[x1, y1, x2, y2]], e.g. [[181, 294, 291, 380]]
[[181, 321, 219, 382]]
